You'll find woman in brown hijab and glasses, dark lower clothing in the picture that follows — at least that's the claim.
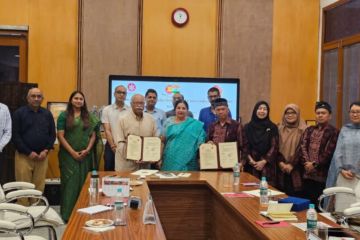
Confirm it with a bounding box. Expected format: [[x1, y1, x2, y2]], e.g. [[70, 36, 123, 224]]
[[278, 104, 306, 196]]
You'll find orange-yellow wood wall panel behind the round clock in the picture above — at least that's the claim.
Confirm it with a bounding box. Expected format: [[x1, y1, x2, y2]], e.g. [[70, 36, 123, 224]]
[[141, 0, 219, 77]]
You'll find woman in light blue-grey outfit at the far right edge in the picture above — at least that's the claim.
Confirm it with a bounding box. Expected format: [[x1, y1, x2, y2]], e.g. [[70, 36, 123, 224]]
[[326, 101, 360, 211]]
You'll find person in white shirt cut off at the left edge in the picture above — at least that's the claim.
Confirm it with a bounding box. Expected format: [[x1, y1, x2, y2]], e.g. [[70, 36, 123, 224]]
[[0, 103, 11, 154]]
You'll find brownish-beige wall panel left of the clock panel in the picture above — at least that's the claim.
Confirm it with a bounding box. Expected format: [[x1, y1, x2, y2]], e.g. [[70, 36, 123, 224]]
[[79, 0, 140, 107]]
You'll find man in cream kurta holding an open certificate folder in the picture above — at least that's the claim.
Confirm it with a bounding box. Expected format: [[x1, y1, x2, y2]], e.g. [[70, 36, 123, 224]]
[[115, 94, 161, 171]]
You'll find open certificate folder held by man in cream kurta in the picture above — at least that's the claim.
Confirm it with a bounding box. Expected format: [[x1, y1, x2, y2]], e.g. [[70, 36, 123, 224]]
[[126, 135, 161, 162]]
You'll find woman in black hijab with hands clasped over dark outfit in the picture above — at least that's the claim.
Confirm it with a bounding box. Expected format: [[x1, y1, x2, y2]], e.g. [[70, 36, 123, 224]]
[[245, 101, 279, 186]]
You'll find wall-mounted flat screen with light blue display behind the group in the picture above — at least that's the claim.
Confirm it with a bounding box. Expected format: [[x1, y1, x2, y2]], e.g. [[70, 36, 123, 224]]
[[109, 75, 240, 119]]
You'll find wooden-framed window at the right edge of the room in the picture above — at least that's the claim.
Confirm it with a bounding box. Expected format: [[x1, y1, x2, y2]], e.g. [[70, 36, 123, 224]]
[[320, 0, 360, 127]]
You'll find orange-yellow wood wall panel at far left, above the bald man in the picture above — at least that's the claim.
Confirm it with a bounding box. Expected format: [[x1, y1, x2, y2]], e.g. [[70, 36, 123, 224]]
[[0, 0, 78, 105]]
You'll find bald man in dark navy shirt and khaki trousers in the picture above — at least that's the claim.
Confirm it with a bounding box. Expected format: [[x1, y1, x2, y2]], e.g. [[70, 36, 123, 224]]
[[12, 88, 56, 205]]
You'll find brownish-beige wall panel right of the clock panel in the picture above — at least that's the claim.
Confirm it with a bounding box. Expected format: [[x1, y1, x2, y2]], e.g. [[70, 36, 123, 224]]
[[220, 0, 273, 123]]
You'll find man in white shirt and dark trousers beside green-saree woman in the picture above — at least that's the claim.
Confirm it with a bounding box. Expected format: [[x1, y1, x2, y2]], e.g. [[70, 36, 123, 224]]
[[101, 85, 129, 171]]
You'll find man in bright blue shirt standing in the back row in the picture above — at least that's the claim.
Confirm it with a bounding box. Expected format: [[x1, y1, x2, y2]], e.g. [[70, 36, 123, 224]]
[[199, 87, 231, 132]]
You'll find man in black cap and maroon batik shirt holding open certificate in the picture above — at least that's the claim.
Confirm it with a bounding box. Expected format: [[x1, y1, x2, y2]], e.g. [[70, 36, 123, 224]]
[[204, 98, 248, 169]]
